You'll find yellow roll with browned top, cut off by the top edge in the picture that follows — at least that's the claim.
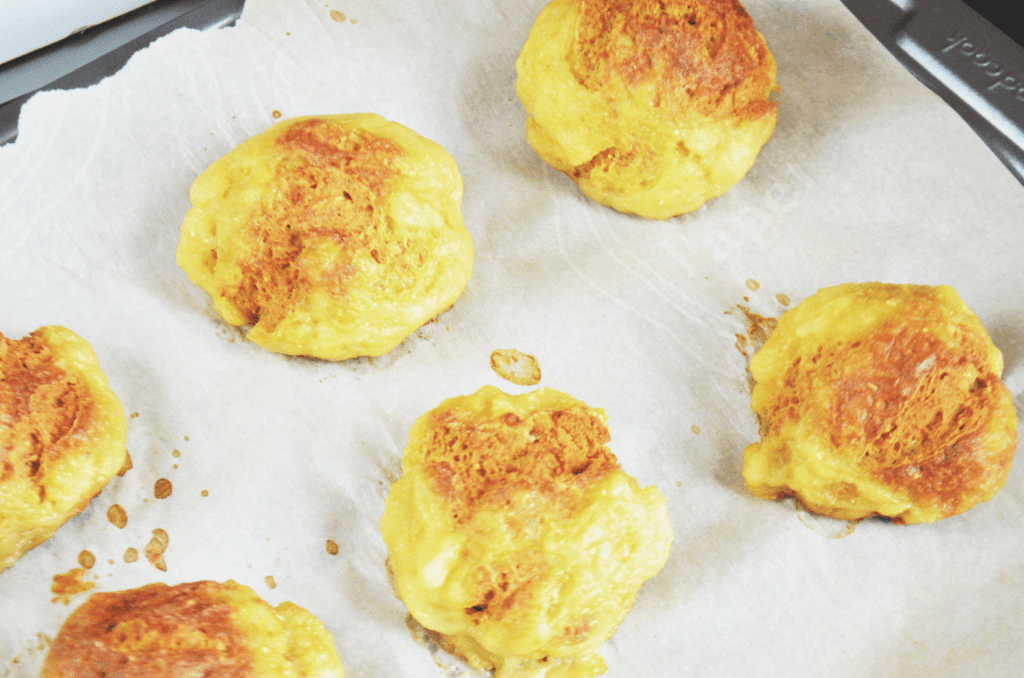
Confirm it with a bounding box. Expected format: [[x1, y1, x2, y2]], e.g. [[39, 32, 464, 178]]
[[516, 0, 778, 219]]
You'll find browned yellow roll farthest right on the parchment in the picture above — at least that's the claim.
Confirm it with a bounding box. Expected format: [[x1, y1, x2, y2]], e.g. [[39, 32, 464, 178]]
[[743, 283, 1017, 523]]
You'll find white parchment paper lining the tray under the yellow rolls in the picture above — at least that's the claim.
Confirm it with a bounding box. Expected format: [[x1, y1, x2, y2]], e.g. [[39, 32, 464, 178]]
[[0, 0, 1024, 678]]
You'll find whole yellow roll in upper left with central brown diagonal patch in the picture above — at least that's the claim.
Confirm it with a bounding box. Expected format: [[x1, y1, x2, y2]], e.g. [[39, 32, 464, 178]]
[[177, 114, 473, 361]]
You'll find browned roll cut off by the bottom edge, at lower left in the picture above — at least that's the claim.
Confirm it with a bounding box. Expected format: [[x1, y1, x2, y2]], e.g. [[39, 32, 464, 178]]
[[42, 581, 344, 678]]
